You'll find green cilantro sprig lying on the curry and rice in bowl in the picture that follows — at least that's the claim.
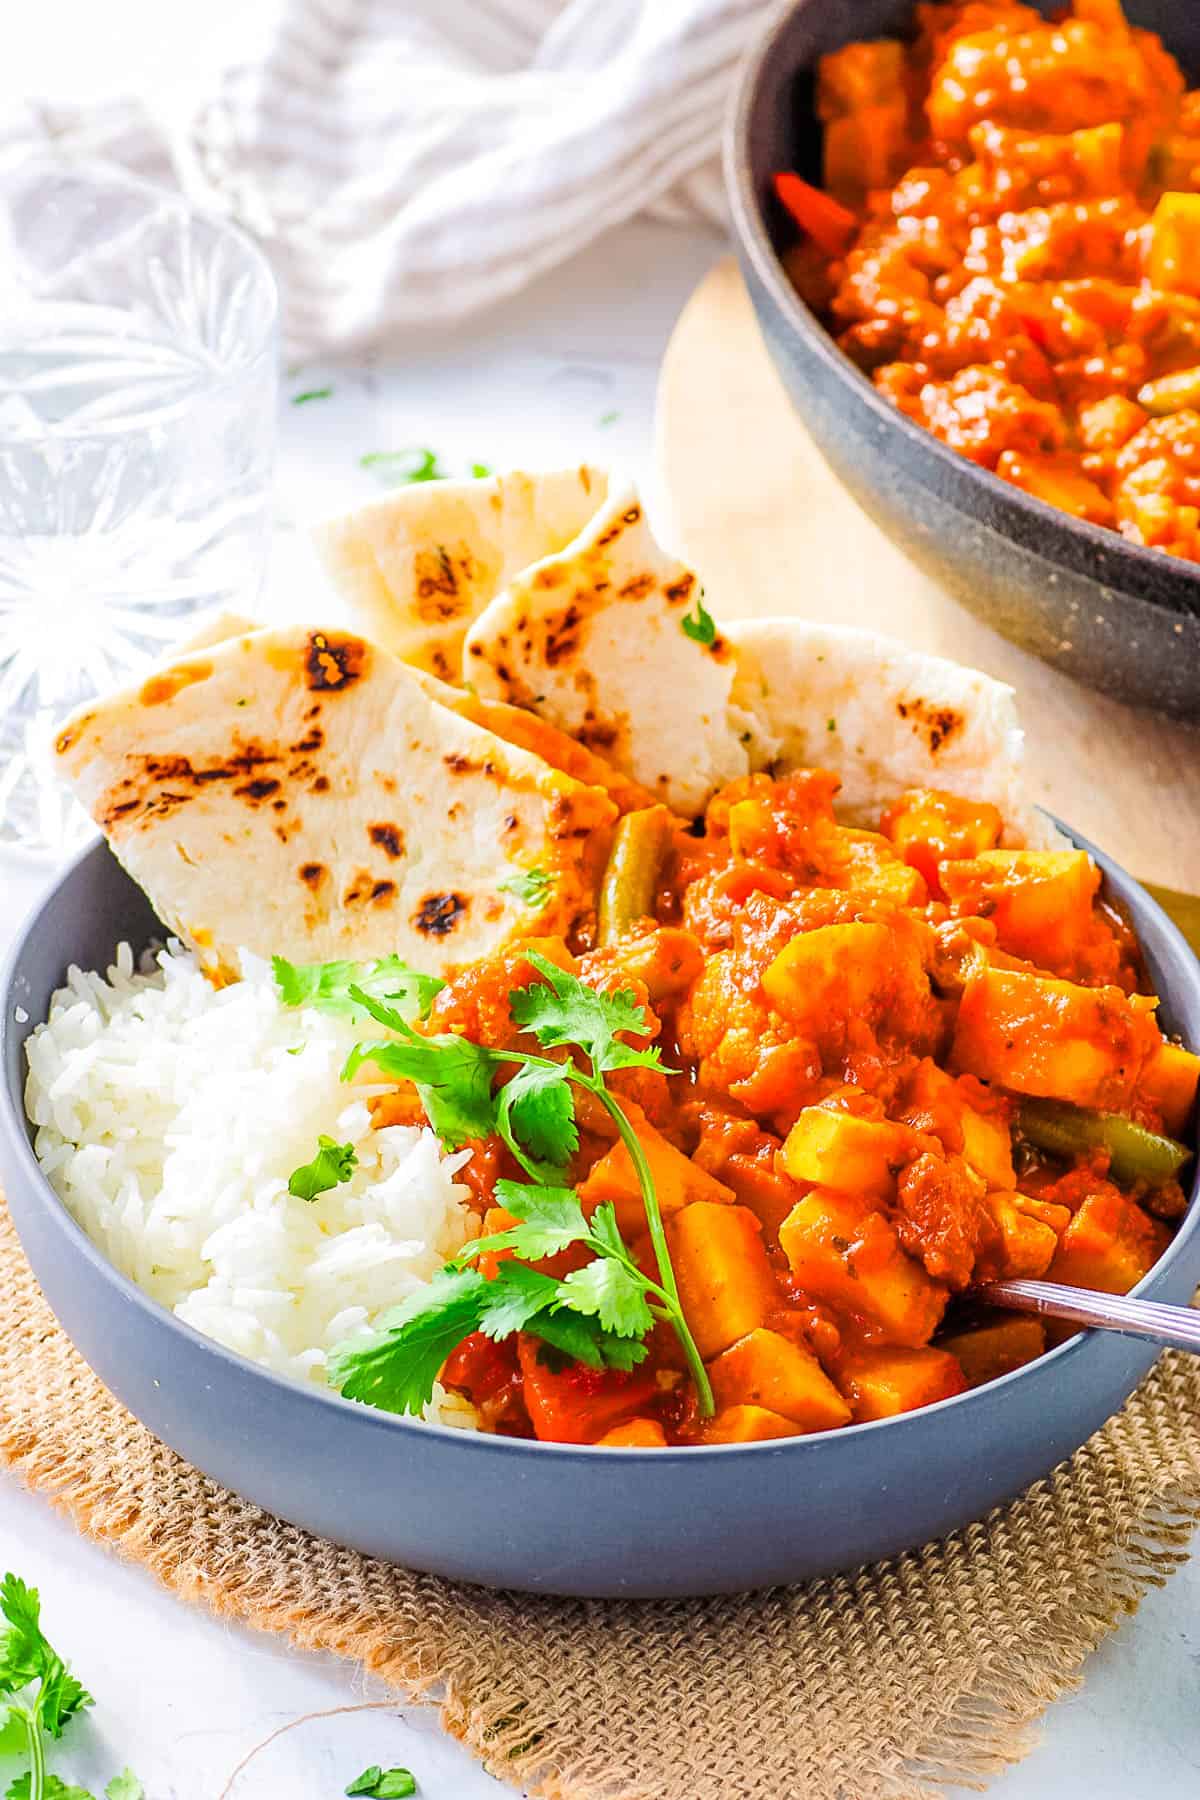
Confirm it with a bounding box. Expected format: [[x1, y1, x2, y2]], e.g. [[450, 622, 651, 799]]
[[331, 950, 712, 1415]]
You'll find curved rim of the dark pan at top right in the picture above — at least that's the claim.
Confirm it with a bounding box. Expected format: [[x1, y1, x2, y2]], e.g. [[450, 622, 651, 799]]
[[721, 0, 1200, 619]]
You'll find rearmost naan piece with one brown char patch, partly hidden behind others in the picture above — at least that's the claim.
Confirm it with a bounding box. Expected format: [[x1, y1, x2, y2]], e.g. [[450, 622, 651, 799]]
[[313, 464, 608, 680]]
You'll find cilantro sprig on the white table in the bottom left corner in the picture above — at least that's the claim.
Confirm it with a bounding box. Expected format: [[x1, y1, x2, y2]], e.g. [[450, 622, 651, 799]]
[[0, 1575, 144, 1800]]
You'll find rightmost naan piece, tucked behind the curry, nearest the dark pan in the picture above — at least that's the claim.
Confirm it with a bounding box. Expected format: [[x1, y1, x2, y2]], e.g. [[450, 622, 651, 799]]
[[725, 619, 1060, 844]]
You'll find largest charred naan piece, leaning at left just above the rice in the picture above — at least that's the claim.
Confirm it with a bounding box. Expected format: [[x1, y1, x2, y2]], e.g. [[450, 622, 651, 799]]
[[56, 626, 615, 974]]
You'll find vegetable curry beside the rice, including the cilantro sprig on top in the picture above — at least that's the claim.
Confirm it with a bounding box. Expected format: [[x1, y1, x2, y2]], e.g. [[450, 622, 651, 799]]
[[338, 770, 1200, 1447]]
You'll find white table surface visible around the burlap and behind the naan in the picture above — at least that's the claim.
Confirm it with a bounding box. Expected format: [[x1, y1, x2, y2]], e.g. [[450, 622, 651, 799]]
[[0, 91, 1200, 1800]]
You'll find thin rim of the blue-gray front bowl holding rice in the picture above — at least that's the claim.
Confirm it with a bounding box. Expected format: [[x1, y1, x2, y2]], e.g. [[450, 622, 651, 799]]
[[0, 835, 1200, 1467]]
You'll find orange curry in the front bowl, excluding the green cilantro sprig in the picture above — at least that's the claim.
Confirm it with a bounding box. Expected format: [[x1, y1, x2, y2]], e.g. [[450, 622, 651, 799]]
[[380, 770, 1200, 1445]]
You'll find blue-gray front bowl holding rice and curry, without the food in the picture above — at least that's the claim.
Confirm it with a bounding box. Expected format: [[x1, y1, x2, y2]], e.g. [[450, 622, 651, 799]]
[[0, 844, 1200, 1595]]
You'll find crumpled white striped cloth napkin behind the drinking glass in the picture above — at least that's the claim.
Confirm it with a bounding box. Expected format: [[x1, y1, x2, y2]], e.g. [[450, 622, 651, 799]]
[[0, 0, 780, 355]]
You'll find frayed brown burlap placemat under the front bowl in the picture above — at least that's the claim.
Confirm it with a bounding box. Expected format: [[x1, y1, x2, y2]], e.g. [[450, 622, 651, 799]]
[[0, 1206, 1200, 1800]]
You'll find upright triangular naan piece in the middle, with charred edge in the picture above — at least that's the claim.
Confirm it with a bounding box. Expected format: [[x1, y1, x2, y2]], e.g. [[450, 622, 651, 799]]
[[462, 490, 750, 814]]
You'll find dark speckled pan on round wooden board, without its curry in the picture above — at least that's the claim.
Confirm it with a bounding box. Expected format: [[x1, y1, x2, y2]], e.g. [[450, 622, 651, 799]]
[[725, 0, 1200, 718]]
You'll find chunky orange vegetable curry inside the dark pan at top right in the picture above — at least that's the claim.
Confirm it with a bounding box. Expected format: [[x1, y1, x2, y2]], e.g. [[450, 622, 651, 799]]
[[775, 0, 1200, 562]]
